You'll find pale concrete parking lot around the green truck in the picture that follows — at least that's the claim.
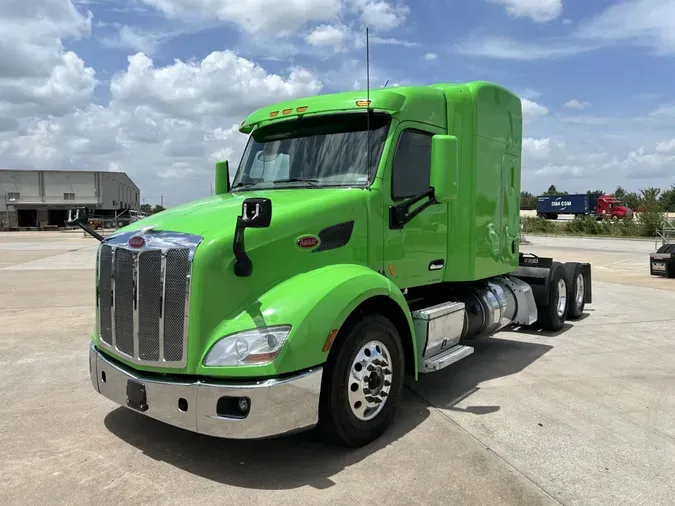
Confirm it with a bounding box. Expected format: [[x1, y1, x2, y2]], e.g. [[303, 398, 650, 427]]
[[0, 232, 675, 505]]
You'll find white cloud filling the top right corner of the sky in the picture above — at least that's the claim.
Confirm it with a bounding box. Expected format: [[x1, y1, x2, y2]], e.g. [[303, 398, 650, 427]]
[[576, 0, 675, 54]]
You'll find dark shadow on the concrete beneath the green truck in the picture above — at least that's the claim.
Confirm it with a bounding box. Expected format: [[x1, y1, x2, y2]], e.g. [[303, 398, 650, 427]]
[[104, 337, 552, 490]]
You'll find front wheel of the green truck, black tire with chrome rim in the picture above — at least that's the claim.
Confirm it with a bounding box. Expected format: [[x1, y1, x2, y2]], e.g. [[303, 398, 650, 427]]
[[318, 313, 405, 448]]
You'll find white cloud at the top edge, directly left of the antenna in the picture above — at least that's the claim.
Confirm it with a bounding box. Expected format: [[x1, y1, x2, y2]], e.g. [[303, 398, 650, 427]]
[[141, 0, 341, 35]]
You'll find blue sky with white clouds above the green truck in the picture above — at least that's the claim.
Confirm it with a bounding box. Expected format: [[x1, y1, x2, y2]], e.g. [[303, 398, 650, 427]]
[[0, 0, 675, 205]]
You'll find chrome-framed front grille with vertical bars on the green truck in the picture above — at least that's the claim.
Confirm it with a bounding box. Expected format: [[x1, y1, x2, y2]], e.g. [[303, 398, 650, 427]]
[[97, 232, 201, 367]]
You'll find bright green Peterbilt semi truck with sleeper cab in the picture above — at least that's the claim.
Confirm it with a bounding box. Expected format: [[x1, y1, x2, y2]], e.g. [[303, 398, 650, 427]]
[[78, 82, 592, 447]]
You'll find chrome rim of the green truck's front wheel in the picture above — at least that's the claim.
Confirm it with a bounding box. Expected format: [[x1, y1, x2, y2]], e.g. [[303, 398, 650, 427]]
[[347, 341, 393, 421]]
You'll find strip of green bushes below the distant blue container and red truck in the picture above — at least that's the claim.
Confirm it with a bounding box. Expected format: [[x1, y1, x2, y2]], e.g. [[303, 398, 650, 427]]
[[524, 216, 662, 238]]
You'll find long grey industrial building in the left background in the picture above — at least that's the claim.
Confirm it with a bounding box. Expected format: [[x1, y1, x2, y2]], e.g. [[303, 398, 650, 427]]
[[0, 169, 140, 230]]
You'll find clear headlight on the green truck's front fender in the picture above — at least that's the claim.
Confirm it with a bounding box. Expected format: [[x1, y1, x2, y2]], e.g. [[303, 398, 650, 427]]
[[204, 326, 291, 366]]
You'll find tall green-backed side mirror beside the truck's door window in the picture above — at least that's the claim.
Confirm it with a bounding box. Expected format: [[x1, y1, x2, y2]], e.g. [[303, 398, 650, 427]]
[[431, 135, 459, 204]]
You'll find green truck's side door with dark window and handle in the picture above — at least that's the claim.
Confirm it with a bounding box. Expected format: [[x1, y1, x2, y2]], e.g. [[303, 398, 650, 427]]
[[382, 121, 448, 288]]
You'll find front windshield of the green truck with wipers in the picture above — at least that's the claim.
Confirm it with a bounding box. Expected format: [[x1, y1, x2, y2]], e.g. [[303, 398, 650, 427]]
[[232, 112, 391, 190]]
